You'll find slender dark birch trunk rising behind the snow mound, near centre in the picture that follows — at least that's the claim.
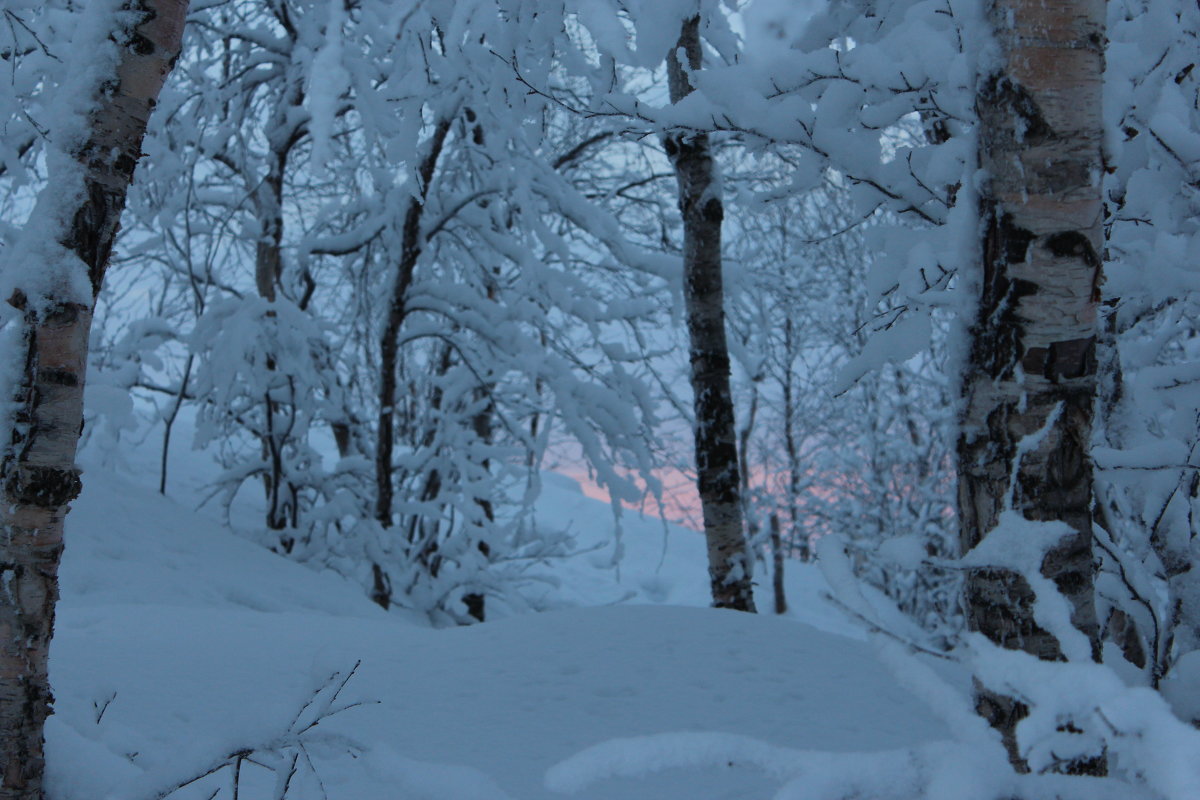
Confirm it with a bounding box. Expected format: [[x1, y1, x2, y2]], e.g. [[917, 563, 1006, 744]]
[[662, 17, 755, 612]]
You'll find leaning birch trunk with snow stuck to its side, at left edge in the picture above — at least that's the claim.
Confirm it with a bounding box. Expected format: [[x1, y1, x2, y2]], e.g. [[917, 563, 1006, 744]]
[[0, 0, 187, 800]]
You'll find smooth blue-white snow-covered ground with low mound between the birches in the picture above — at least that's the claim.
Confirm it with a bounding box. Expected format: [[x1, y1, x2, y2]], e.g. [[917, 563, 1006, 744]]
[[47, 424, 946, 800]]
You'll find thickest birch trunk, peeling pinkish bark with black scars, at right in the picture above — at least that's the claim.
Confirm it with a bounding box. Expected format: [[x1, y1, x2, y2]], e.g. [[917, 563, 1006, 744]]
[[958, 0, 1105, 774]]
